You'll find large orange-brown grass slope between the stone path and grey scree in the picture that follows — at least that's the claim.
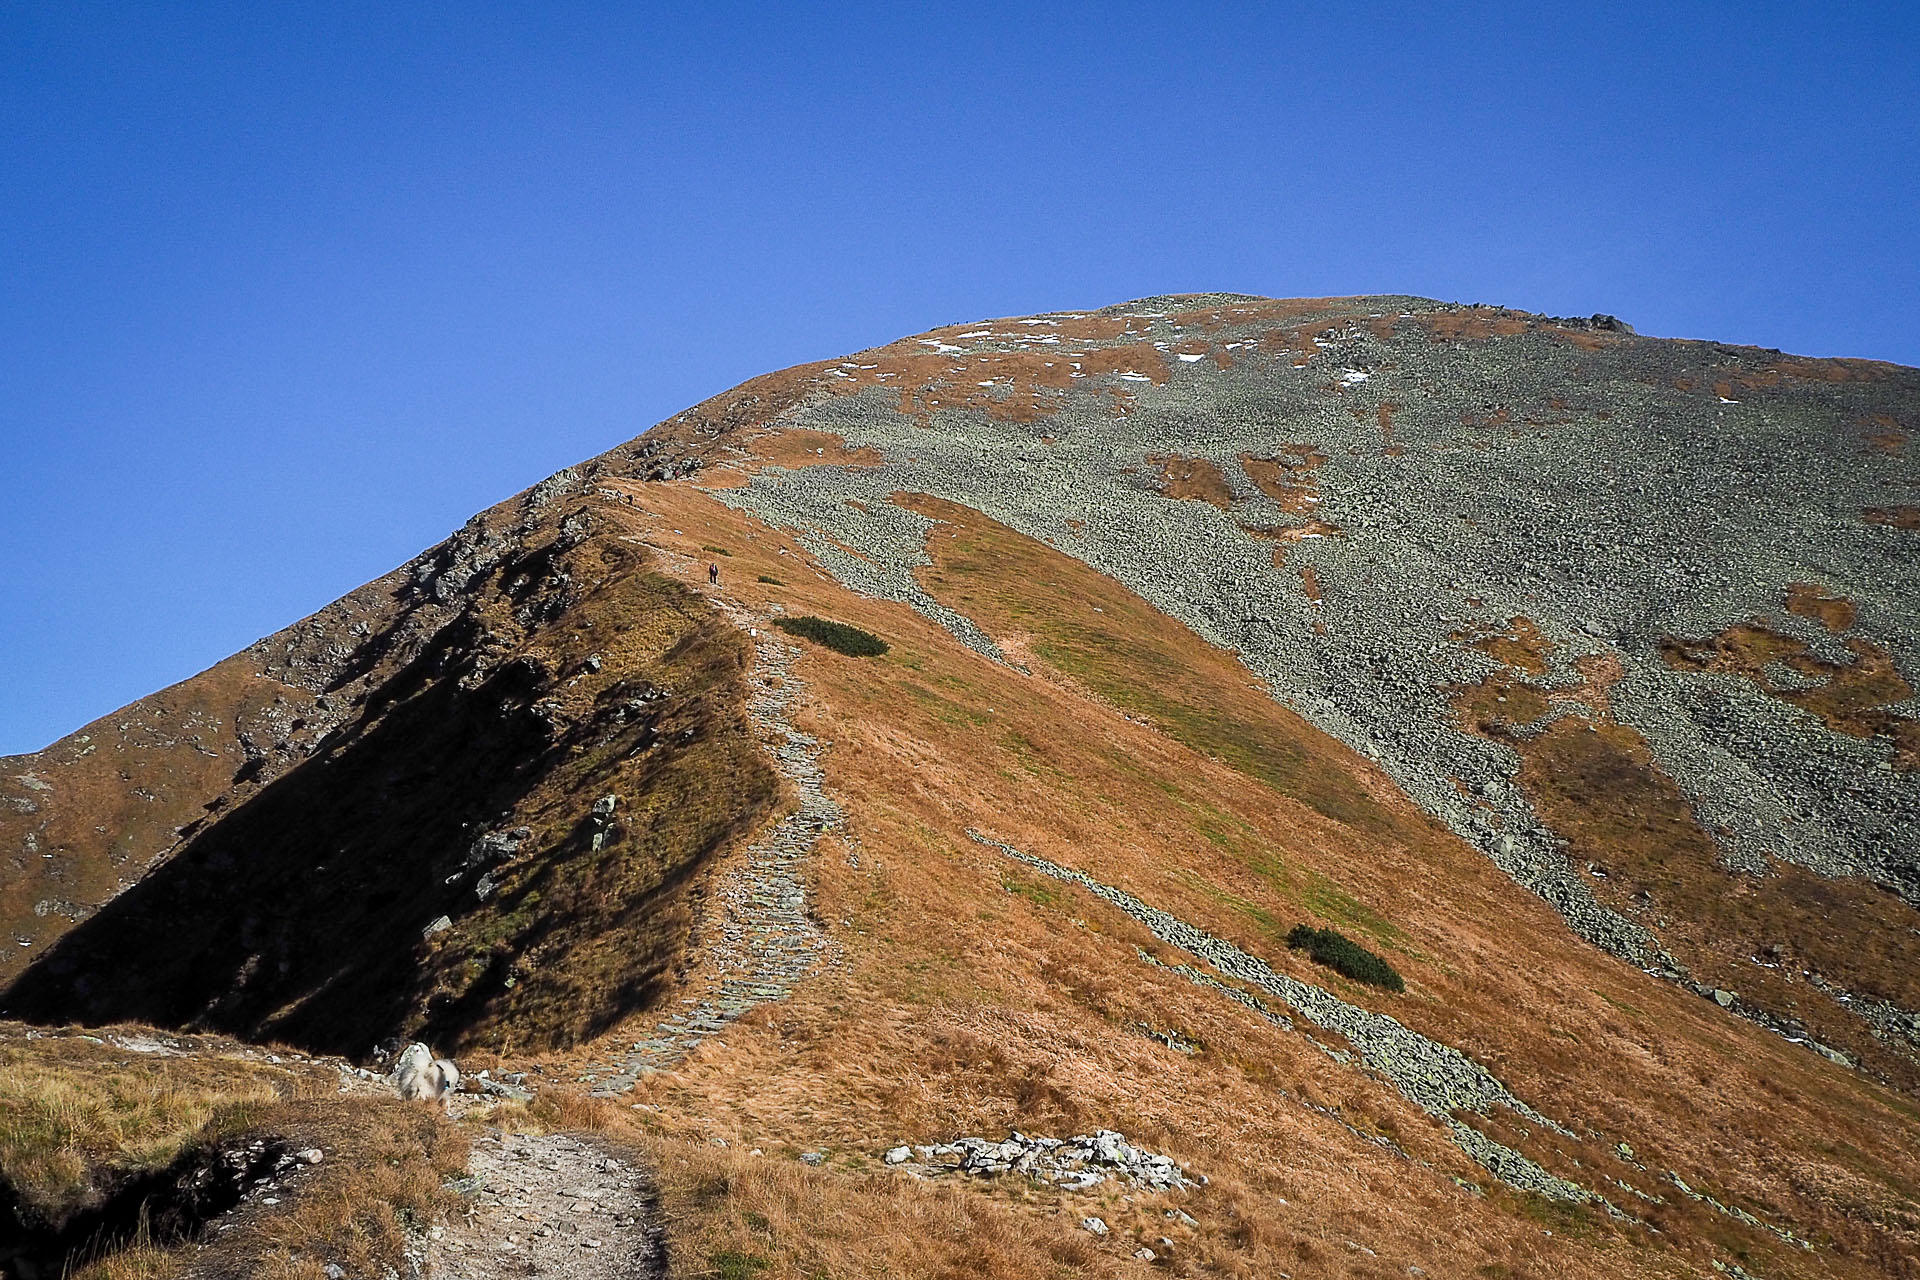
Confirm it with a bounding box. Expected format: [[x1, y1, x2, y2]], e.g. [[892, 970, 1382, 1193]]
[[579, 486, 1920, 1276]]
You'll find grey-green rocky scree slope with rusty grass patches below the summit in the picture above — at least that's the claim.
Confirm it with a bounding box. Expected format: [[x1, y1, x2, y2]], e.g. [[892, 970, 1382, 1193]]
[[660, 297, 1920, 1082]]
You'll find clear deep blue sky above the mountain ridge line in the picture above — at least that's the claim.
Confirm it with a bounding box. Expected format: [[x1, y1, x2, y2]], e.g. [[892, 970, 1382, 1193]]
[[0, 0, 1920, 752]]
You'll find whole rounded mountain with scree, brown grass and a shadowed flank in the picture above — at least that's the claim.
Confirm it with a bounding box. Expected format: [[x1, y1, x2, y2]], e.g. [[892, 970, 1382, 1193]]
[[0, 294, 1920, 1276]]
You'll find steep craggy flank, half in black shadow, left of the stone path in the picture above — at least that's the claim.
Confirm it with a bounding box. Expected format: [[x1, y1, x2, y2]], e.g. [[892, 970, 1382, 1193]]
[[0, 521, 778, 1055]]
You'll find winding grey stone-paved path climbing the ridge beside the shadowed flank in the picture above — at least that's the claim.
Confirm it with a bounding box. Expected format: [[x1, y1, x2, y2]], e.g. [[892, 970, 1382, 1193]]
[[588, 597, 843, 1098]]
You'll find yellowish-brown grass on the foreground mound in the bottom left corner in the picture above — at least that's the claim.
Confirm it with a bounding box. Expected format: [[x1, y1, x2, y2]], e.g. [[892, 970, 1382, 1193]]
[[0, 1025, 467, 1280]]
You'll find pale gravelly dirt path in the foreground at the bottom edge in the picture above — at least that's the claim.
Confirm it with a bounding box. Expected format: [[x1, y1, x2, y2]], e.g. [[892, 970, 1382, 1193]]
[[426, 1128, 666, 1280]]
